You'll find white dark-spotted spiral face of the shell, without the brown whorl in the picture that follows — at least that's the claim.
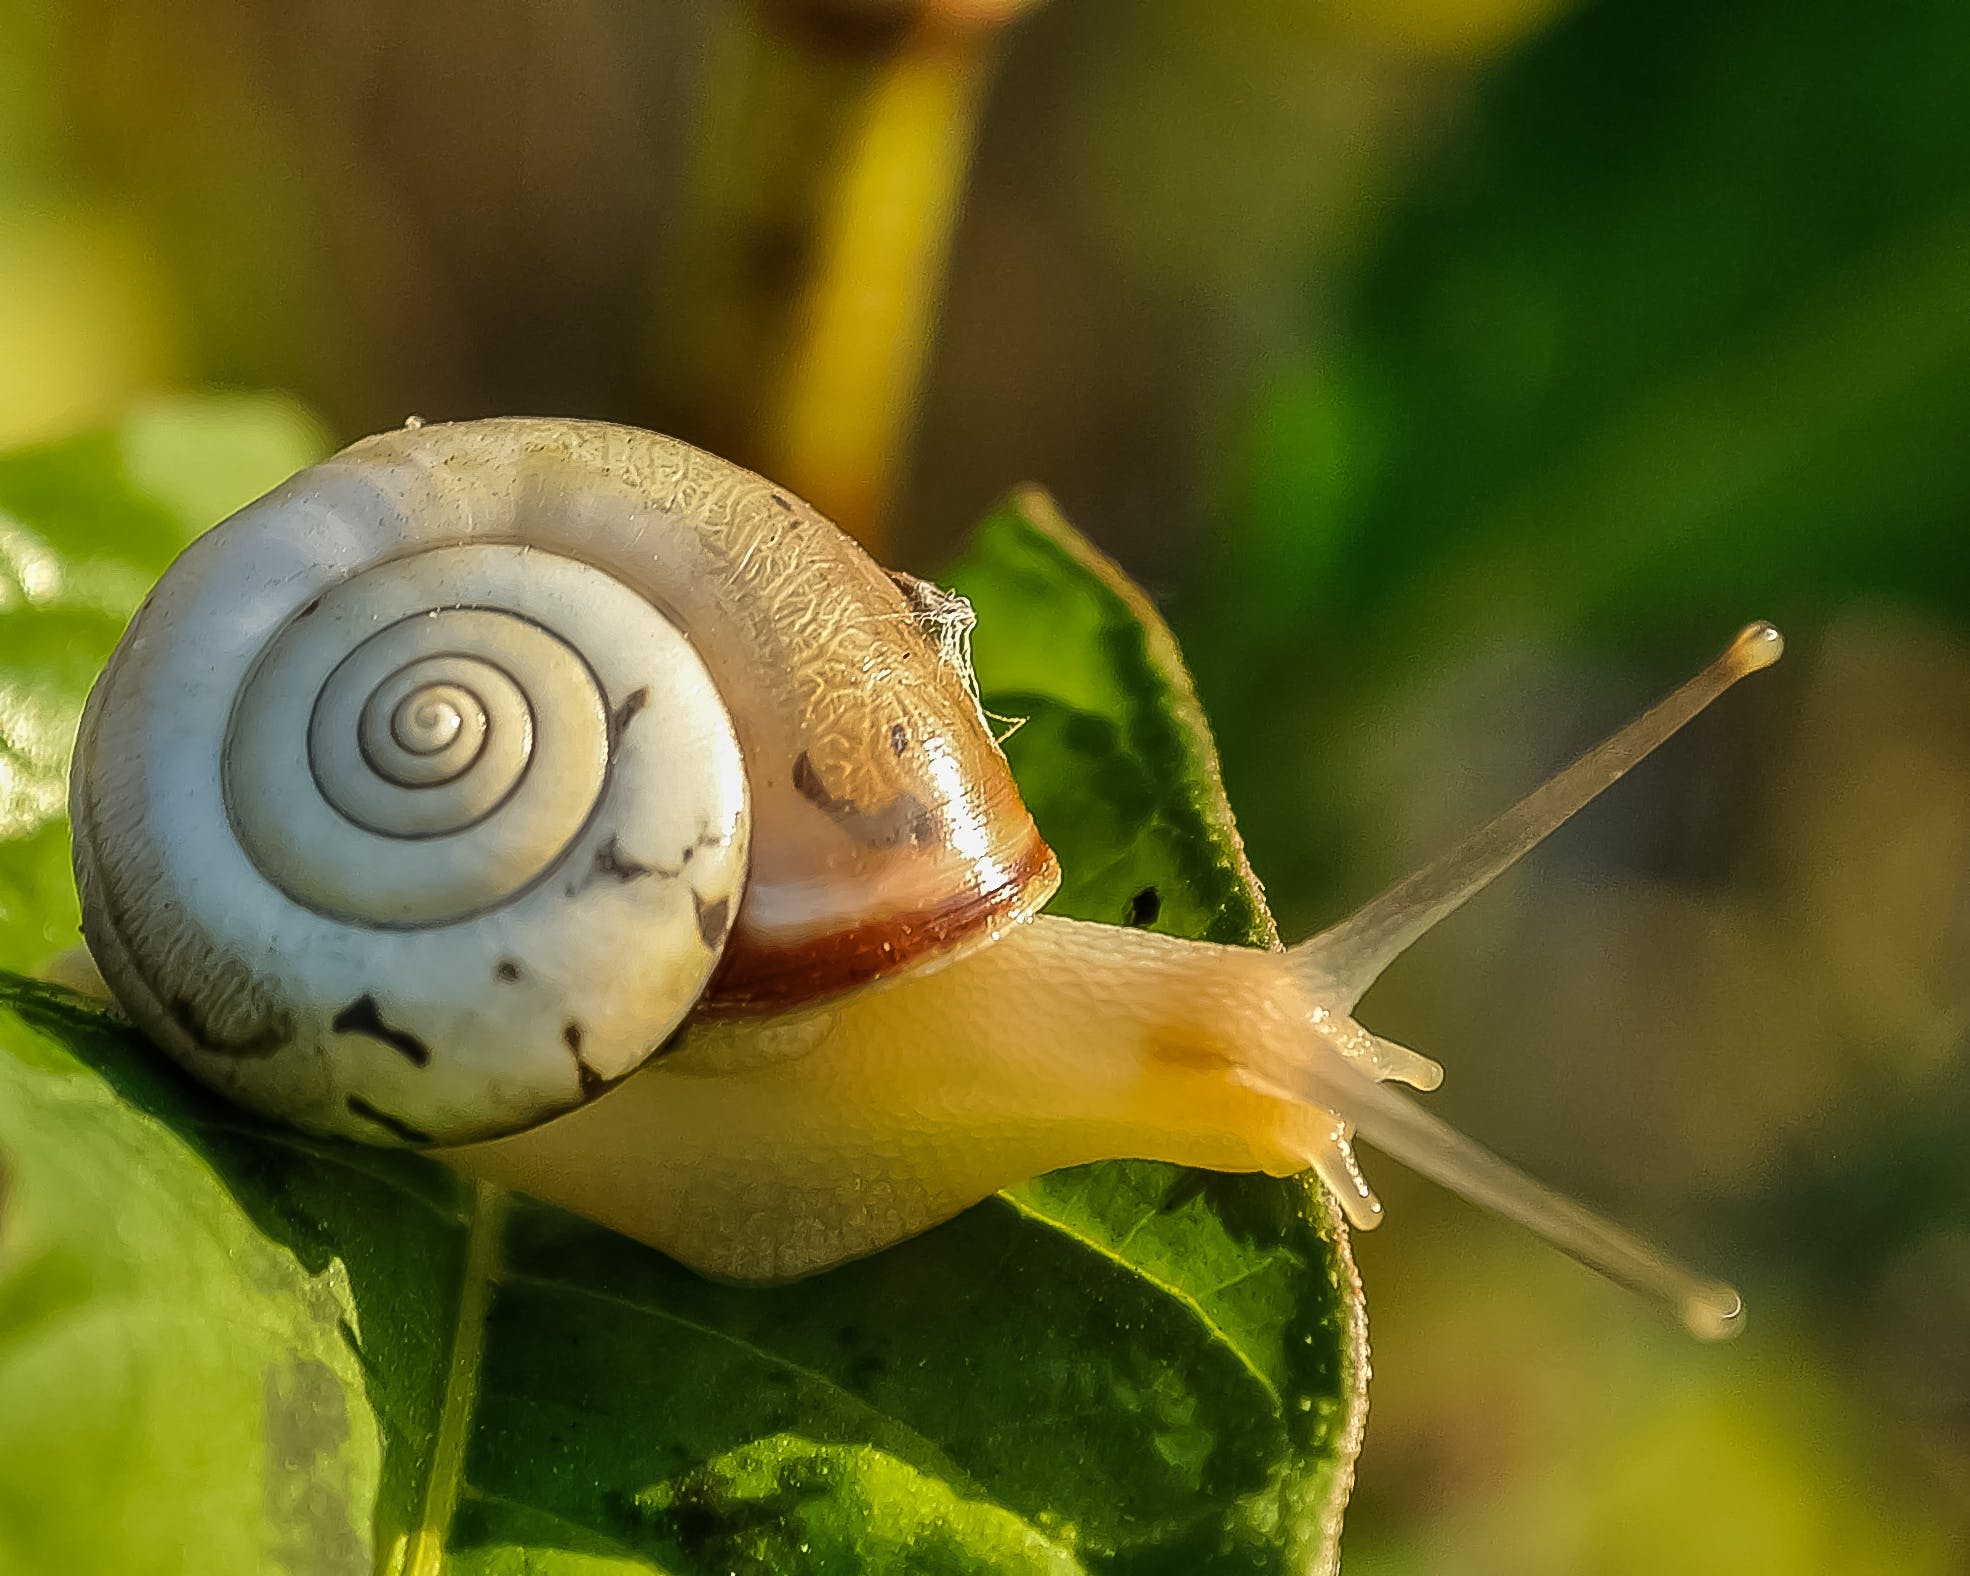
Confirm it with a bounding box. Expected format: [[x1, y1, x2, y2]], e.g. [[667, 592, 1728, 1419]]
[[71, 437, 751, 1143]]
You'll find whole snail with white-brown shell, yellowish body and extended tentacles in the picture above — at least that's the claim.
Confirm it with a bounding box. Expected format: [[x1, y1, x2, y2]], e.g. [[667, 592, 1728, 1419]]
[[71, 420, 1781, 1336]]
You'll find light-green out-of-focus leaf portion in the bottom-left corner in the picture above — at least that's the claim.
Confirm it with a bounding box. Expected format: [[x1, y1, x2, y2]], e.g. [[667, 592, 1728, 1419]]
[[0, 975, 403, 1576]]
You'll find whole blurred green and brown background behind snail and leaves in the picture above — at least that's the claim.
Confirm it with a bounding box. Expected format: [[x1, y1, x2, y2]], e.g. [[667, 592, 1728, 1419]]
[[0, 0, 1970, 1576]]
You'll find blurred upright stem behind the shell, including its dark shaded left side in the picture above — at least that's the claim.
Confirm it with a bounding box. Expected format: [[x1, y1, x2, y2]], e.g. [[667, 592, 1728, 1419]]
[[658, 0, 1034, 548]]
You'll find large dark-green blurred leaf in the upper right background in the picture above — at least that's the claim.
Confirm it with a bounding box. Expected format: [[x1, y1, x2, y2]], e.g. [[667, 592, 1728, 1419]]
[[1221, 0, 1970, 689]]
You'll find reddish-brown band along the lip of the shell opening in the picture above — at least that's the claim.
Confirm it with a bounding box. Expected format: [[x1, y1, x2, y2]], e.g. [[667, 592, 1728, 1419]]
[[699, 829, 1060, 1017]]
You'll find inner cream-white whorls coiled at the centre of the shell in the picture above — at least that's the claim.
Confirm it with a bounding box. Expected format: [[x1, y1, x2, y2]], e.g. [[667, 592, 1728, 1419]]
[[225, 544, 634, 926]]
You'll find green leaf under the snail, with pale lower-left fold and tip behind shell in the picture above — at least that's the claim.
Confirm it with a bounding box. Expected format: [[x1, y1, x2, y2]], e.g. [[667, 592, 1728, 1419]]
[[0, 433, 1365, 1576]]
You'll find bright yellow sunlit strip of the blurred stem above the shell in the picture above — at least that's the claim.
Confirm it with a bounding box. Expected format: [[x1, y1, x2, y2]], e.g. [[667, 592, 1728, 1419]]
[[766, 28, 997, 548]]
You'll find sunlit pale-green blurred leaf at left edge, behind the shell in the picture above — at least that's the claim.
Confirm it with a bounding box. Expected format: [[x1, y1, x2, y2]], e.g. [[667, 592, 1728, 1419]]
[[0, 396, 323, 969]]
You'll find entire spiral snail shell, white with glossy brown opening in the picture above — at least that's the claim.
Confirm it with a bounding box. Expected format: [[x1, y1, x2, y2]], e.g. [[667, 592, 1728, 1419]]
[[71, 420, 1058, 1143]]
